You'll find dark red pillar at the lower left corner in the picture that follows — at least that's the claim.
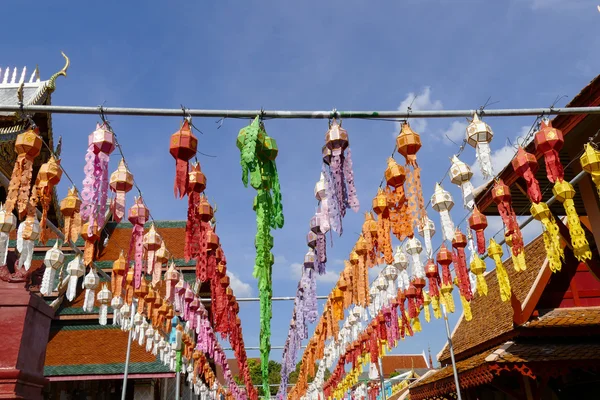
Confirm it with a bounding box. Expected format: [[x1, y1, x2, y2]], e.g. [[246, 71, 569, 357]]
[[0, 280, 54, 400]]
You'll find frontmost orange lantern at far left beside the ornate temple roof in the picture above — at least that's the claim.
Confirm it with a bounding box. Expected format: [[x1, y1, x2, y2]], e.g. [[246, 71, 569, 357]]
[[4, 128, 42, 218]]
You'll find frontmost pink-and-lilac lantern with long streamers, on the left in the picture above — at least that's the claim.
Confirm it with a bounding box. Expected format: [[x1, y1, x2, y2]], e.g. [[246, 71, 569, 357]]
[[81, 123, 115, 235]]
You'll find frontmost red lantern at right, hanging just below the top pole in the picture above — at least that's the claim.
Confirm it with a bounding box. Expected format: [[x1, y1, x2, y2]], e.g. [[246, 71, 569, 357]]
[[534, 119, 565, 183]]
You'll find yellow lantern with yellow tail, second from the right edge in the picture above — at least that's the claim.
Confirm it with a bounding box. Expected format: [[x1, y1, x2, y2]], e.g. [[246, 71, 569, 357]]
[[552, 180, 592, 262]]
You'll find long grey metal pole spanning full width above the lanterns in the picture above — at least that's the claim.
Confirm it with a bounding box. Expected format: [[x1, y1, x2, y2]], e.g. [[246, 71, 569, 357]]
[[0, 105, 600, 119]]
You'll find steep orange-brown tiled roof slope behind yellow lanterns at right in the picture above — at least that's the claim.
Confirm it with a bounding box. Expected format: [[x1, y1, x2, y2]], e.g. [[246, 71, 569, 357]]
[[438, 236, 546, 364]]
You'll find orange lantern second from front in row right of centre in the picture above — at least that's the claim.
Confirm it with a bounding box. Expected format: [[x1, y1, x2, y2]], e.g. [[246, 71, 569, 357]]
[[385, 157, 413, 241]]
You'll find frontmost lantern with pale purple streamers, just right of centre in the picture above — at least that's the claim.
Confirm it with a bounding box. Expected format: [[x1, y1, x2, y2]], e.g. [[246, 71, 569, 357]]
[[323, 119, 360, 235]]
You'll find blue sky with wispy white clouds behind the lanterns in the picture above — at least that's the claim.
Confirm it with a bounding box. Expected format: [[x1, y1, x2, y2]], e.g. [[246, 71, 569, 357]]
[[0, 0, 600, 368]]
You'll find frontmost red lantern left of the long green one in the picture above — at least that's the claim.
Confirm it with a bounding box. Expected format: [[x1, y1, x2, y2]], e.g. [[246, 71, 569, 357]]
[[169, 119, 198, 199]]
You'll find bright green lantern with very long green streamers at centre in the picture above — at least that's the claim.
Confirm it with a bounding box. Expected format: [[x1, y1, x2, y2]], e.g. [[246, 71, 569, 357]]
[[236, 116, 284, 393]]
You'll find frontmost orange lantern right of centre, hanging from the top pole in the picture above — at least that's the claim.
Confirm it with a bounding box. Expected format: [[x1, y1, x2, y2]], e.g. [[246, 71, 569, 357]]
[[396, 121, 427, 236]]
